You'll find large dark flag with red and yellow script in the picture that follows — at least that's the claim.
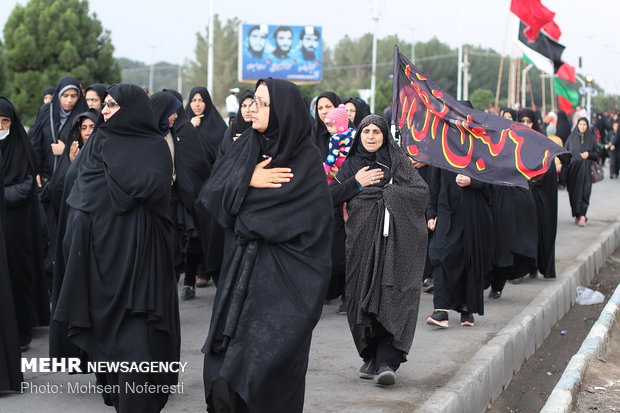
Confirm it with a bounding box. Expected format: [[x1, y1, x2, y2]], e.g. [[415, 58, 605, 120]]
[[392, 47, 570, 188]]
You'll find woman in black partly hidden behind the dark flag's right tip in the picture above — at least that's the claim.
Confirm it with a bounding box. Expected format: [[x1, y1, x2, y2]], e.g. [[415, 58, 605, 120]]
[[517, 108, 558, 282]]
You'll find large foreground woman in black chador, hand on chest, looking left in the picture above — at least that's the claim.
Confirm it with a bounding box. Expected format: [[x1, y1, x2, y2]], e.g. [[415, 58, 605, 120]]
[[201, 78, 332, 413]]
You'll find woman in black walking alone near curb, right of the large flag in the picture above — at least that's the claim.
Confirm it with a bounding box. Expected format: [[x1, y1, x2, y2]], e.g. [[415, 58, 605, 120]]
[[564, 118, 596, 227]]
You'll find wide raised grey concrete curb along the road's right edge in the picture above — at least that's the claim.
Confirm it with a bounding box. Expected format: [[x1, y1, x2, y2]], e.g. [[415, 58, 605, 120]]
[[416, 222, 620, 413]]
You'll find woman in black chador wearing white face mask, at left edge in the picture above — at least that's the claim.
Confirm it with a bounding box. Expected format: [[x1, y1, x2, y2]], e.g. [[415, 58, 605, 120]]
[[0, 98, 50, 348]]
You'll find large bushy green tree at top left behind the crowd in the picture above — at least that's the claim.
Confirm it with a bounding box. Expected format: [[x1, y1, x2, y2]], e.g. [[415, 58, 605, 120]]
[[4, 0, 120, 123]]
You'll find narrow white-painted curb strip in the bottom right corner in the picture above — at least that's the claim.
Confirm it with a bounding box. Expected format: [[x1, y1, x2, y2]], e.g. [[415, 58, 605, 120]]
[[541, 276, 620, 413]]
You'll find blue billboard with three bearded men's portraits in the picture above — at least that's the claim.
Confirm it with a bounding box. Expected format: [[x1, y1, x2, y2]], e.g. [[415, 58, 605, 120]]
[[239, 24, 323, 83]]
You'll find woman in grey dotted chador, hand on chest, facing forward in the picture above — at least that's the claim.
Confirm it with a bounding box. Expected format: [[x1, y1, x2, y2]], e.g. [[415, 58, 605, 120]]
[[330, 115, 428, 386]]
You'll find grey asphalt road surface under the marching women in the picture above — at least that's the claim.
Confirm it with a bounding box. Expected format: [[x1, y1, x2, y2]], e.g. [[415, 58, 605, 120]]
[[0, 169, 620, 413]]
